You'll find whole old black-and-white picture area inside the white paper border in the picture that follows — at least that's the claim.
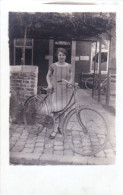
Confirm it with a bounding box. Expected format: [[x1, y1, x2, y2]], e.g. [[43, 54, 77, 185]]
[[8, 11, 116, 166]]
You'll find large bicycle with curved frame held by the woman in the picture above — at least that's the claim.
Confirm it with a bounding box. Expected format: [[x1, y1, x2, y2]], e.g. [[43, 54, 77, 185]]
[[24, 80, 108, 156]]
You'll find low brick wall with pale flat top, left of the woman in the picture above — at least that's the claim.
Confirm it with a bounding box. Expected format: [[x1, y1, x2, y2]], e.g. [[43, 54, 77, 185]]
[[10, 65, 38, 102]]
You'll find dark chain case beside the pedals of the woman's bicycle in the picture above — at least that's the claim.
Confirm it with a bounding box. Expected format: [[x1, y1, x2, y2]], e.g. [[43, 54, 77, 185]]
[[33, 113, 54, 129]]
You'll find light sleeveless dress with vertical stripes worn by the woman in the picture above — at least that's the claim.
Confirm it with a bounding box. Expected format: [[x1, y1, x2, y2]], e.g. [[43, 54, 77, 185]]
[[49, 62, 72, 112]]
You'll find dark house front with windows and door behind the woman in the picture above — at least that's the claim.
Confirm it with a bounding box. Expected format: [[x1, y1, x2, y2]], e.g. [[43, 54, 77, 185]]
[[11, 38, 110, 86]]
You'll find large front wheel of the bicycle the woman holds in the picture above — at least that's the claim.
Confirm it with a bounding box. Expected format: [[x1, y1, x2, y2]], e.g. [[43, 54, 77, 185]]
[[63, 107, 108, 156]]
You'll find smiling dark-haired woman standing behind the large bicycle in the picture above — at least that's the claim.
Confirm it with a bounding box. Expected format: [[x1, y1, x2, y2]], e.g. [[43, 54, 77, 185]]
[[46, 48, 73, 139]]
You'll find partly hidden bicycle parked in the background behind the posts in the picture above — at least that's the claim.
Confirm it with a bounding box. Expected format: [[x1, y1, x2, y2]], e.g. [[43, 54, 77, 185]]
[[85, 76, 107, 94]]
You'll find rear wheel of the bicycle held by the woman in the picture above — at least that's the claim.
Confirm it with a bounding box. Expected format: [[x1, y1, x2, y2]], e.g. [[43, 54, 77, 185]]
[[24, 95, 49, 134]]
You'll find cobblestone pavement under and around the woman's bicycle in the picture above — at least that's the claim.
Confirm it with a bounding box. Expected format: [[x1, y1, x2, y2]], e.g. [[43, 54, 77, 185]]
[[10, 89, 116, 165]]
